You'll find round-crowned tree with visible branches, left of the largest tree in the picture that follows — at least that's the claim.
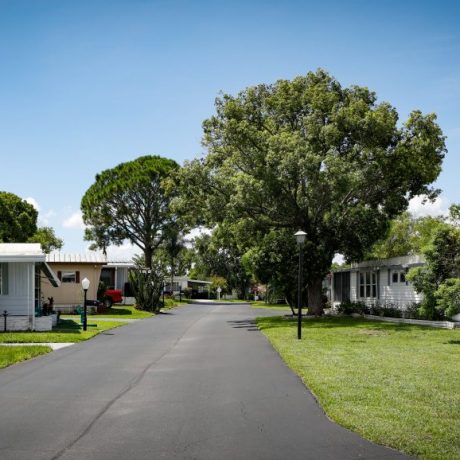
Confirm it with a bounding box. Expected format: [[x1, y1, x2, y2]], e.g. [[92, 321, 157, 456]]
[[81, 156, 179, 268]]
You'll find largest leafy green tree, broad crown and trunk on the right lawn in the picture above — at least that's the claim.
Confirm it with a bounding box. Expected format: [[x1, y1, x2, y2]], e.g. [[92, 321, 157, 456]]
[[177, 70, 445, 314]]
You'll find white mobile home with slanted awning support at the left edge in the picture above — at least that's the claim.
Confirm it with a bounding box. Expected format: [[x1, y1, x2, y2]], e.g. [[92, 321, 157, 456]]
[[0, 243, 60, 330]]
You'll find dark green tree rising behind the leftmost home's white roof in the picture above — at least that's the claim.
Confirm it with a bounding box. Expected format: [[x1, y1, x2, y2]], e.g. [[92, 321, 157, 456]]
[[0, 192, 38, 243]]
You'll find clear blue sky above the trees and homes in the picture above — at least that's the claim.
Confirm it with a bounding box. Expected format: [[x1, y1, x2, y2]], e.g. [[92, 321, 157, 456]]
[[0, 0, 460, 254]]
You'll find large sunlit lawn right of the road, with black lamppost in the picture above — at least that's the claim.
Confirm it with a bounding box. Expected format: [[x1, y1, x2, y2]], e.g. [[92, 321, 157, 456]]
[[257, 317, 460, 460]]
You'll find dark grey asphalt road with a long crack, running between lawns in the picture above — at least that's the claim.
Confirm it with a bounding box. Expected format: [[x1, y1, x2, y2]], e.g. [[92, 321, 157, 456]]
[[0, 304, 405, 460]]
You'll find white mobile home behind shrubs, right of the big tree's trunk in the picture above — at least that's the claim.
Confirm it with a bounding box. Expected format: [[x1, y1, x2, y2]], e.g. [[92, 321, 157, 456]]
[[330, 256, 424, 308]]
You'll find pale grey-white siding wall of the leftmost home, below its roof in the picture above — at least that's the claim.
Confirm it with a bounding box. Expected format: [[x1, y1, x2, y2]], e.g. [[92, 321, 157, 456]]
[[0, 262, 35, 316]]
